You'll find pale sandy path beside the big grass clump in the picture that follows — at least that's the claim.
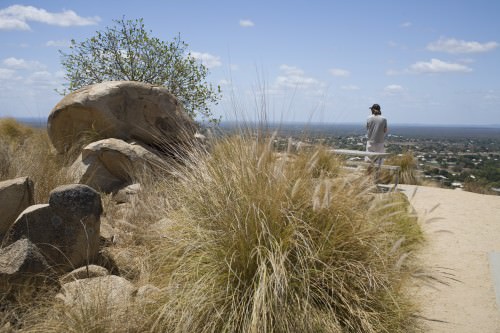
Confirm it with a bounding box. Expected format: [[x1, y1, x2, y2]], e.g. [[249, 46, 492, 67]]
[[400, 185, 500, 333]]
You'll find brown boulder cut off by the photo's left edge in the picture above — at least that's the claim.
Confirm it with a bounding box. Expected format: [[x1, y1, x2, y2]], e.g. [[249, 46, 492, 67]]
[[0, 177, 34, 236]]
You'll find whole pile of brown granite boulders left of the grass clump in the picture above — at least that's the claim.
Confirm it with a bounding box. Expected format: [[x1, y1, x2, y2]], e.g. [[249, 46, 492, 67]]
[[0, 81, 205, 312]]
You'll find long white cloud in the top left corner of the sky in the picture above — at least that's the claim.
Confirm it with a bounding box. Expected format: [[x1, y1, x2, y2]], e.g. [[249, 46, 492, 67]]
[[0, 5, 101, 30]]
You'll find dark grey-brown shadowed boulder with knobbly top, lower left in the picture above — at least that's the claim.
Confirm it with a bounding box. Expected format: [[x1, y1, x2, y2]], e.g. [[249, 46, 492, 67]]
[[5, 184, 103, 271]]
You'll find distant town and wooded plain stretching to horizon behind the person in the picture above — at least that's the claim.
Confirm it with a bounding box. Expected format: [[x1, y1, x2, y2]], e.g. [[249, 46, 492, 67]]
[[221, 124, 500, 195]]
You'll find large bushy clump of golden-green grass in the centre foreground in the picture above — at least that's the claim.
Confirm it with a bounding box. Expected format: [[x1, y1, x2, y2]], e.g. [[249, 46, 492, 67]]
[[151, 133, 419, 333]]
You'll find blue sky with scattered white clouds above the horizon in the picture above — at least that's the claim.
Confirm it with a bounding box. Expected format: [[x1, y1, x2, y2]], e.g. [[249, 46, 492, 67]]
[[0, 0, 500, 125]]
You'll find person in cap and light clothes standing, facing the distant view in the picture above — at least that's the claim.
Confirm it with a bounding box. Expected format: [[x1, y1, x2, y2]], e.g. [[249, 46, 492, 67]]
[[365, 104, 387, 166]]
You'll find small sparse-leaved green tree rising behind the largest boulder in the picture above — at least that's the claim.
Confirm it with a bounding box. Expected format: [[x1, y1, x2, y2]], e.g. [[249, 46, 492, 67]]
[[59, 18, 220, 123]]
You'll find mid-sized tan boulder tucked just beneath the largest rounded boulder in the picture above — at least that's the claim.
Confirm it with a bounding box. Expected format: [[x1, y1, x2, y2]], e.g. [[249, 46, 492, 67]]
[[70, 138, 165, 193]]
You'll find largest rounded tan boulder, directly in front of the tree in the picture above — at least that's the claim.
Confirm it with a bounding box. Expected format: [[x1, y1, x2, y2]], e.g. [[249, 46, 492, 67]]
[[48, 81, 196, 152]]
